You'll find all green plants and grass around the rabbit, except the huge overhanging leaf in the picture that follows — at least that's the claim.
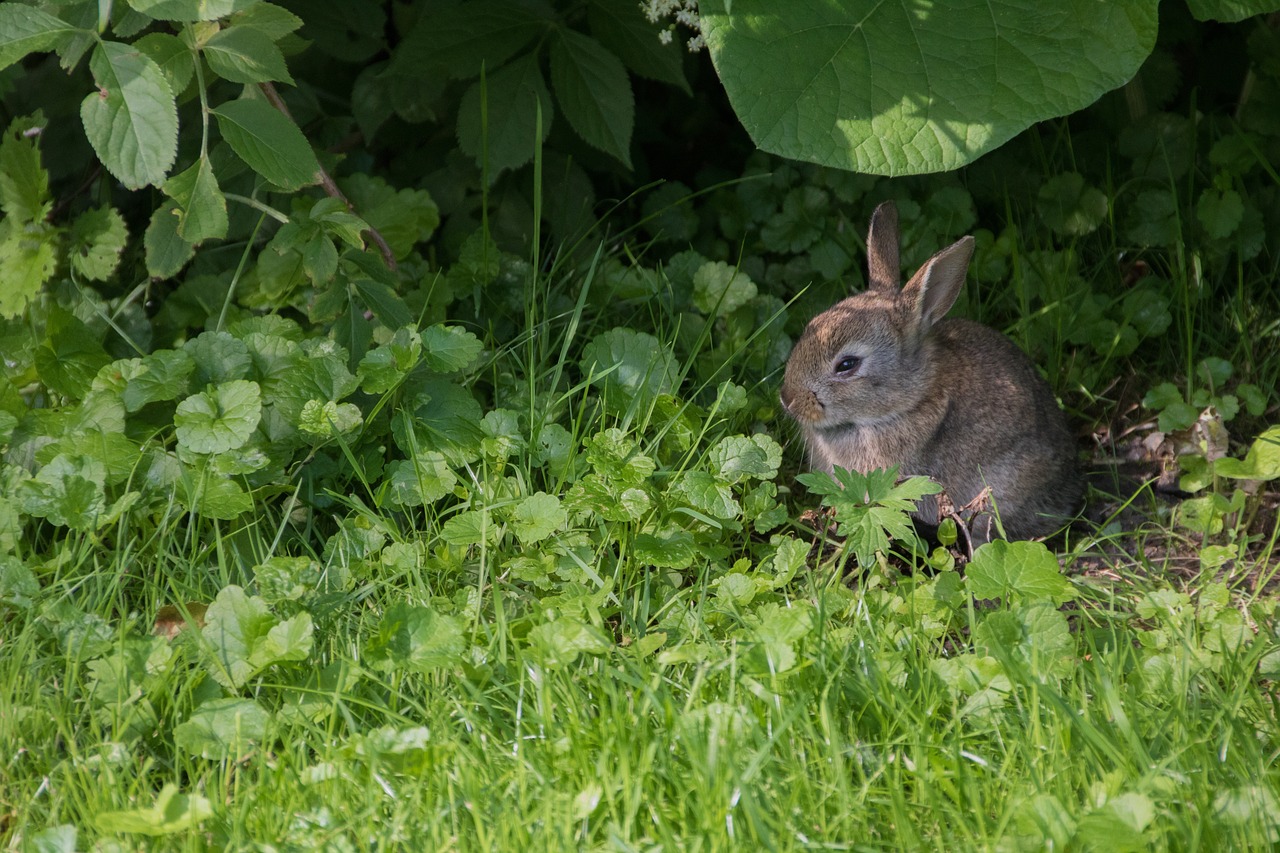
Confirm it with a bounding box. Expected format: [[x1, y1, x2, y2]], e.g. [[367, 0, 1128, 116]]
[[0, 0, 1280, 849]]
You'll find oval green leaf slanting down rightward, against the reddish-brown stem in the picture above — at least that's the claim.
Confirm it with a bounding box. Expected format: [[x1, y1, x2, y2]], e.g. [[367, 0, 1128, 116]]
[[210, 99, 320, 191]]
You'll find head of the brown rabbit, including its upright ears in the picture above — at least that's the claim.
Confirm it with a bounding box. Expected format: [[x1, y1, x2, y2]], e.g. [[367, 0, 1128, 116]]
[[781, 201, 973, 434]]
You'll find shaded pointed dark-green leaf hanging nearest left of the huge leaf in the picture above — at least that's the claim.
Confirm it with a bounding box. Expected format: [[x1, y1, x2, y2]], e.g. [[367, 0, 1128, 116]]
[[550, 29, 635, 169]]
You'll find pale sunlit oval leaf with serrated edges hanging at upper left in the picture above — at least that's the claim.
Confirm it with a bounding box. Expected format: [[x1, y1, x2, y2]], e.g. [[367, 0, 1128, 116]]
[[81, 41, 178, 190]]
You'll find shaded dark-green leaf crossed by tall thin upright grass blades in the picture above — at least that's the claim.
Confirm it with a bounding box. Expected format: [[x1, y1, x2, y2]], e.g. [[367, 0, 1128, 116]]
[[458, 54, 554, 179]]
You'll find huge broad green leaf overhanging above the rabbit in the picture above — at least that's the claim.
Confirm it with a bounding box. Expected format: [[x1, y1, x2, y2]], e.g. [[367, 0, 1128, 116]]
[[701, 0, 1158, 175]]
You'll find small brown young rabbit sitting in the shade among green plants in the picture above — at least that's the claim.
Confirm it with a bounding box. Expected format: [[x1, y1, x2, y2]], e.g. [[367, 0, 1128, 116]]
[[780, 201, 1084, 543]]
